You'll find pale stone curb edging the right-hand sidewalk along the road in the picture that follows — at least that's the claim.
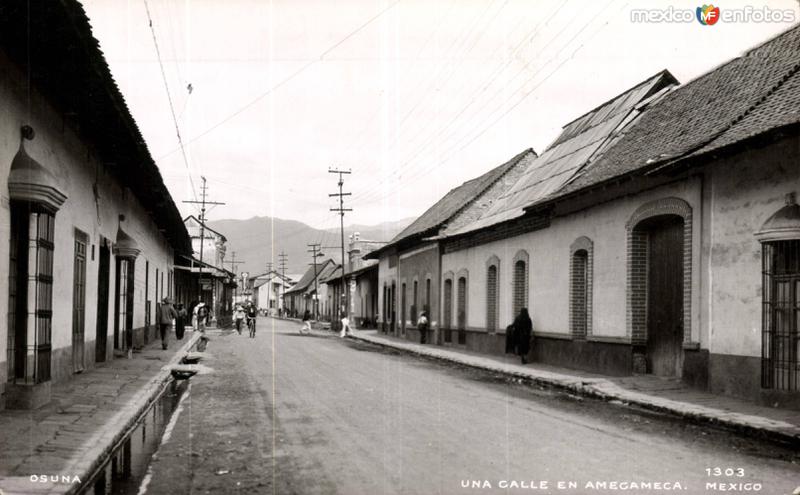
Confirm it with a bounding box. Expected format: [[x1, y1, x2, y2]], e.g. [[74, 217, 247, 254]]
[[351, 334, 800, 448]]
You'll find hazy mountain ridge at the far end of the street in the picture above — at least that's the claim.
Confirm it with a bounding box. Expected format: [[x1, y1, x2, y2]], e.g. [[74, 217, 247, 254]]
[[208, 217, 414, 274]]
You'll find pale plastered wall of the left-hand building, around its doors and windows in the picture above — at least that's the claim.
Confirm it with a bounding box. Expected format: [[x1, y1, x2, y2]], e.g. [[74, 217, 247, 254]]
[[0, 50, 173, 382]]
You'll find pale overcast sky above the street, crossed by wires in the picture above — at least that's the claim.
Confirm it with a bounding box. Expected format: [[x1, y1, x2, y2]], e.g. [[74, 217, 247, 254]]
[[82, 0, 800, 232]]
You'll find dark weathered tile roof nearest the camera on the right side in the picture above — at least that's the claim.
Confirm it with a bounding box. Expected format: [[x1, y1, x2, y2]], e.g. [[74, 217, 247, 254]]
[[548, 23, 800, 199]]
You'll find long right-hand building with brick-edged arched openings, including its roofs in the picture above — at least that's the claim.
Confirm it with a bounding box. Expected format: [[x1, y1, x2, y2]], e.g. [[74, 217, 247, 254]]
[[440, 27, 800, 408]]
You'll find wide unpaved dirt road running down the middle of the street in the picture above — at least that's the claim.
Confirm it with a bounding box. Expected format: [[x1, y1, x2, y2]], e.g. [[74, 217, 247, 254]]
[[147, 319, 800, 495]]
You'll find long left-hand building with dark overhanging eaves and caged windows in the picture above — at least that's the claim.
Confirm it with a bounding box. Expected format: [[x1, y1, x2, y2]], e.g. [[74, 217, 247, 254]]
[[0, 0, 191, 408]]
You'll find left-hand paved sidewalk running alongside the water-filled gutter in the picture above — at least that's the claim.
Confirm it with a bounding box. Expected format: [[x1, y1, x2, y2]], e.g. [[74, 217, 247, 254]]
[[0, 330, 200, 494]]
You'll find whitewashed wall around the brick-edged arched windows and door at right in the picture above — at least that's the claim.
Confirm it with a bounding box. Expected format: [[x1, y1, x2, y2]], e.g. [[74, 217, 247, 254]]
[[441, 180, 700, 344]]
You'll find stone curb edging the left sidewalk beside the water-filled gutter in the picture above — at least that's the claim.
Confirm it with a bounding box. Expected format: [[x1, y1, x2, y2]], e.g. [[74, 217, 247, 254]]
[[65, 332, 201, 495]]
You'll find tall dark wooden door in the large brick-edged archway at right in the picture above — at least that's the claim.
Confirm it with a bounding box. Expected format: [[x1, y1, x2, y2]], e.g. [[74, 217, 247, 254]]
[[647, 216, 683, 376]]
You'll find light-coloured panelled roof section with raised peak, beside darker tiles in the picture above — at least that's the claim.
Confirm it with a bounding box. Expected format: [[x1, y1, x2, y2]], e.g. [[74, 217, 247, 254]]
[[448, 70, 677, 235]]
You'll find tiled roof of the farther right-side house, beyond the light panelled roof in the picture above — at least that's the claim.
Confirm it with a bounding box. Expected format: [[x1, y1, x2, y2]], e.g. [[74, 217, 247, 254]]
[[382, 149, 536, 249]]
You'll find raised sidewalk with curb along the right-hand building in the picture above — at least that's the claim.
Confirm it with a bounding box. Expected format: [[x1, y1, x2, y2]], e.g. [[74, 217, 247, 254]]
[[346, 330, 800, 447]]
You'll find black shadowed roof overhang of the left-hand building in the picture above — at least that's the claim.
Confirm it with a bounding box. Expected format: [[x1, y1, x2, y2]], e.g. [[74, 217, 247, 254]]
[[0, 0, 192, 254]]
